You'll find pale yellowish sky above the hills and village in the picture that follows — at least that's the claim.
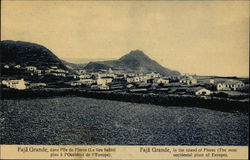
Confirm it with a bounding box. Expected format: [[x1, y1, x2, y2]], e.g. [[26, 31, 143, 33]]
[[1, 0, 249, 77]]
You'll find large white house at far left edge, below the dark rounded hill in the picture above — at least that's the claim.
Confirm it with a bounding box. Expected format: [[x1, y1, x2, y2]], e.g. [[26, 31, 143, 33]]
[[2, 79, 28, 90]]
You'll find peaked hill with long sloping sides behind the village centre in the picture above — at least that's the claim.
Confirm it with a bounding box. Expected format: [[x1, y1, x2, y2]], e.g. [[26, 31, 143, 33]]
[[84, 50, 180, 76]]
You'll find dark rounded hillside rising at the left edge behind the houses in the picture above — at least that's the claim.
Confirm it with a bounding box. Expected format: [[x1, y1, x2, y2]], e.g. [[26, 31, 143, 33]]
[[0, 40, 67, 69]]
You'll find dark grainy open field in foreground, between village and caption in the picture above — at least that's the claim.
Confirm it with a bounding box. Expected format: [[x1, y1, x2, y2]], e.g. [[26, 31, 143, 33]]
[[0, 97, 249, 145]]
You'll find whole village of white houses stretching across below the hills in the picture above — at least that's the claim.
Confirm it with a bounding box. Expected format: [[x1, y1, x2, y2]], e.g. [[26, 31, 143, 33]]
[[0, 64, 249, 99]]
